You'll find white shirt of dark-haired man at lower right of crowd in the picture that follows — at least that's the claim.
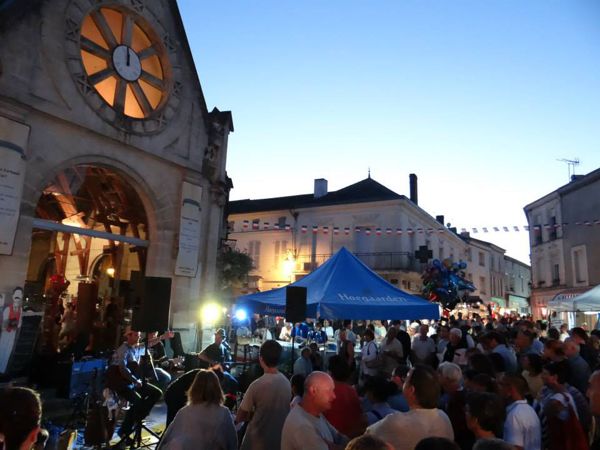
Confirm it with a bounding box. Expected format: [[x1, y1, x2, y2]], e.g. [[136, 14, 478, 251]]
[[504, 400, 542, 450]]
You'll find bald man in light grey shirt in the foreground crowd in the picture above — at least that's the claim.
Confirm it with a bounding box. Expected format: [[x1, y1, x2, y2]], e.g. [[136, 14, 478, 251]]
[[282, 371, 348, 450]]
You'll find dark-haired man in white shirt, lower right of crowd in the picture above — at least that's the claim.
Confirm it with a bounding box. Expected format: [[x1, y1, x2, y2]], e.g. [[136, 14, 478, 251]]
[[498, 374, 542, 450]]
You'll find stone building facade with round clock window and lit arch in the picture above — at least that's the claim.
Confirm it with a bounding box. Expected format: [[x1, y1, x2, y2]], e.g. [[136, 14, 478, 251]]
[[0, 0, 233, 364]]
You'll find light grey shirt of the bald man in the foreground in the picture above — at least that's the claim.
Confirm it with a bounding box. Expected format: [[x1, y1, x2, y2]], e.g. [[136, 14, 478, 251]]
[[282, 405, 348, 450]]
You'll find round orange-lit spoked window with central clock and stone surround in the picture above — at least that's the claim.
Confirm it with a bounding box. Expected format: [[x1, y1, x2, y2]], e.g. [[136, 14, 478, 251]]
[[66, 0, 182, 134]]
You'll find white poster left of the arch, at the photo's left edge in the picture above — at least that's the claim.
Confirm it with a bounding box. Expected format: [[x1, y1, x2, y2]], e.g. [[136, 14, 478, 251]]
[[0, 117, 29, 255]]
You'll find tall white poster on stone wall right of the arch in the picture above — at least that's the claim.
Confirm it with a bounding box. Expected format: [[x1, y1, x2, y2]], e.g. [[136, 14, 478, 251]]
[[175, 181, 202, 277]]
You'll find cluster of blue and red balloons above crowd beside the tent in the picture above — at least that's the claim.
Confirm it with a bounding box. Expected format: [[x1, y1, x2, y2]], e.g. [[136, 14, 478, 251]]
[[421, 258, 475, 309]]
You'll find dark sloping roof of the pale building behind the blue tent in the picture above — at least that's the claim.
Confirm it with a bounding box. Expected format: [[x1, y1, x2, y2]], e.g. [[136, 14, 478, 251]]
[[228, 177, 406, 214]]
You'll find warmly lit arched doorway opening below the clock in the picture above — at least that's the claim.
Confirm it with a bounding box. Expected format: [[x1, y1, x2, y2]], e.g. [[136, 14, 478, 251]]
[[25, 164, 149, 355]]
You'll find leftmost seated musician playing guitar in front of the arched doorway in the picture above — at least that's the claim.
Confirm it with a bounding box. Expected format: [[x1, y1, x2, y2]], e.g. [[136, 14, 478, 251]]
[[106, 330, 162, 448]]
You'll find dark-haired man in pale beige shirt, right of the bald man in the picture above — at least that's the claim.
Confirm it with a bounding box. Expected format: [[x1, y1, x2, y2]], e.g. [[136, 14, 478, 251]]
[[366, 365, 454, 450]]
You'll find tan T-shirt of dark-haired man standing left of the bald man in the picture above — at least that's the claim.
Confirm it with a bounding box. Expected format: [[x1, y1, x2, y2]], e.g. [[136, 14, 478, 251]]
[[240, 372, 290, 450]]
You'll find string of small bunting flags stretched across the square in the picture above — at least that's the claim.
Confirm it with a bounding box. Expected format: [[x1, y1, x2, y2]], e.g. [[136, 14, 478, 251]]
[[233, 219, 600, 236]]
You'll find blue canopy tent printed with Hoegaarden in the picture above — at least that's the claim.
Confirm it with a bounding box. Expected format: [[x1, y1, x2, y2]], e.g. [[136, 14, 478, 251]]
[[236, 247, 440, 320]]
